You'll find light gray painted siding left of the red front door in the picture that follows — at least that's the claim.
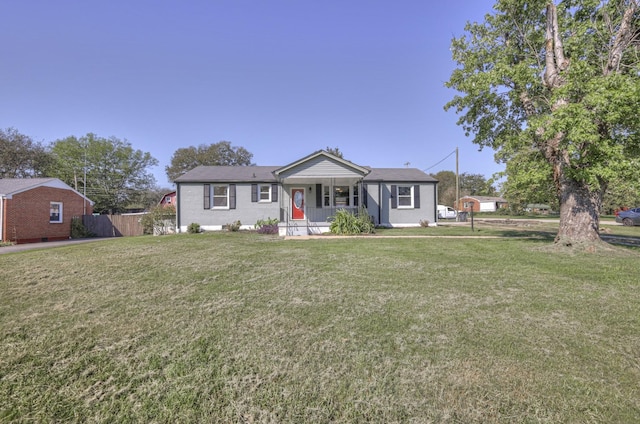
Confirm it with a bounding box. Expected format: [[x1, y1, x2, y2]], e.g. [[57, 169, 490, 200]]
[[178, 183, 280, 232]]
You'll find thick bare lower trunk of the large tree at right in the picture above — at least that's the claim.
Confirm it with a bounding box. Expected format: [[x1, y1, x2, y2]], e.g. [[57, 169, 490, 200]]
[[555, 171, 602, 248]]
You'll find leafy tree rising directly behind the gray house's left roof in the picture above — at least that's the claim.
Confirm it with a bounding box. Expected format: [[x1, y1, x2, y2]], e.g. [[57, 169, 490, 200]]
[[165, 141, 253, 181]]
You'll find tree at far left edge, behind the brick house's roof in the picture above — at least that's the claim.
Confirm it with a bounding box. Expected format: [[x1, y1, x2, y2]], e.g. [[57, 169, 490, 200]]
[[0, 128, 51, 178]]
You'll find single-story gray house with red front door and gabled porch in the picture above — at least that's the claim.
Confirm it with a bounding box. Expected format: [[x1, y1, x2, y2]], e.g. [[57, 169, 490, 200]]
[[175, 150, 438, 235]]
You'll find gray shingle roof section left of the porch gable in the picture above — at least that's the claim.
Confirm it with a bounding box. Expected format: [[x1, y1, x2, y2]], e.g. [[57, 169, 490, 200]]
[[175, 166, 280, 183]]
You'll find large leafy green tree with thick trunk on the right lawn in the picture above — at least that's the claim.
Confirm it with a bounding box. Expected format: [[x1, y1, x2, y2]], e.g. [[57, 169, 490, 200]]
[[445, 0, 640, 247]]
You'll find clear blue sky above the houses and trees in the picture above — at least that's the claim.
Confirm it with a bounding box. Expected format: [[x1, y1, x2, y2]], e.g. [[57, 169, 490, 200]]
[[0, 0, 503, 187]]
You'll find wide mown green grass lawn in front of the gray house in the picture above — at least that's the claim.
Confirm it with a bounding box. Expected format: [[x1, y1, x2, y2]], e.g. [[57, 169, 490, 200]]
[[0, 230, 640, 423]]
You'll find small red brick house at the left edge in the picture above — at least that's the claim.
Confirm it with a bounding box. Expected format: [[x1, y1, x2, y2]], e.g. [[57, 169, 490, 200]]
[[0, 178, 93, 243]]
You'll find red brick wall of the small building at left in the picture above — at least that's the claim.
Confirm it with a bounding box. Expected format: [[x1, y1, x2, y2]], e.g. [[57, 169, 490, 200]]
[[5, 187, 93, 243]]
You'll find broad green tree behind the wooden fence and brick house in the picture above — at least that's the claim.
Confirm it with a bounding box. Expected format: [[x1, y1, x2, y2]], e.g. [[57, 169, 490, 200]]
[[49, 133, 158, 213]]
